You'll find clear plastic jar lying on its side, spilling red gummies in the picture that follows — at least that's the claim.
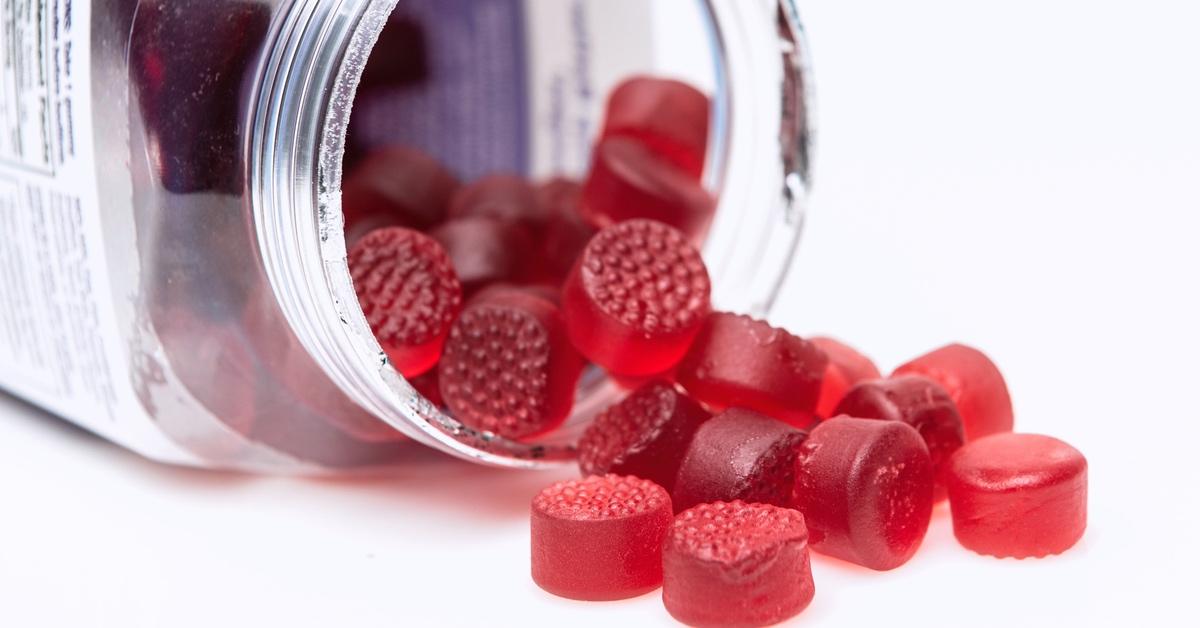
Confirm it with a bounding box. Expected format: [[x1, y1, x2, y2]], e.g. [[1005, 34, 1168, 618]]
[[0, 0, 811, 472]]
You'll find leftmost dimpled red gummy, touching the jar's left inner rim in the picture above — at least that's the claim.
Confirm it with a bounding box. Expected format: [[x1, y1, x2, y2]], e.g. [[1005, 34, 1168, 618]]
[[347, 227, 462, 377]]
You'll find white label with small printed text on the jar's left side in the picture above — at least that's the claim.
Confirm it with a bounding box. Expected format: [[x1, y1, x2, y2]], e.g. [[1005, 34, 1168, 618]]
[[0, 0, 193, 462]]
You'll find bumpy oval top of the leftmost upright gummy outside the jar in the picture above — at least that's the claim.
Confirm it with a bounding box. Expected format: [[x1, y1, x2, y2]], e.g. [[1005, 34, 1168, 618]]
[[533, 474, 671, 521]]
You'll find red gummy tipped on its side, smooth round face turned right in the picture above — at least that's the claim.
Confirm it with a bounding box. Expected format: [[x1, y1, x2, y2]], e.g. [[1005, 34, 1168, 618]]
[[793, 417, 934, 570]]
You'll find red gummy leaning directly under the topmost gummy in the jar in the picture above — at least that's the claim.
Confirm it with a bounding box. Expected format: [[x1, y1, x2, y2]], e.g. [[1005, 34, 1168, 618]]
[[582, 137, 716, 243]]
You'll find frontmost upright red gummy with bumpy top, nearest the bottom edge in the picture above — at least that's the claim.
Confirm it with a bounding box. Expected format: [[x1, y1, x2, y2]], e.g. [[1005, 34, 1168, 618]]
[[662, 502, 816, 627]]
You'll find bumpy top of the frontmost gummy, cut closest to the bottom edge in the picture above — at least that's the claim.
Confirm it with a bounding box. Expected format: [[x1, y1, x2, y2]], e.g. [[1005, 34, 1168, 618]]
[[667, 501, 809, 564]]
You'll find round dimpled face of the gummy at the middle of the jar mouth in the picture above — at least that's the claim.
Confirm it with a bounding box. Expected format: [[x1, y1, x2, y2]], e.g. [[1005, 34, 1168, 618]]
[[580, 220, 712, 334]]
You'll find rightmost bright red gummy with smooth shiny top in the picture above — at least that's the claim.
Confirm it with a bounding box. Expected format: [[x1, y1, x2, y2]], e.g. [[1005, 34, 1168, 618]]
[[947, 433, 1087, 558]]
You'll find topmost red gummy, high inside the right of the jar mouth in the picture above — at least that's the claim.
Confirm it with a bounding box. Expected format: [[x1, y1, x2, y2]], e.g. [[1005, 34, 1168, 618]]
[[602, 77, 712, 181]]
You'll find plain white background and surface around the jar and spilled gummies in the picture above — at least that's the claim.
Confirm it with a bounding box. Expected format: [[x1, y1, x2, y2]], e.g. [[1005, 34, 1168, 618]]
[[0, 0, 1200, 628]]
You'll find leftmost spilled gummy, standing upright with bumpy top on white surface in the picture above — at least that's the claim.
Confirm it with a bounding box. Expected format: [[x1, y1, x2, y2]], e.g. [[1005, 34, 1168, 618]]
[[530, 476, 672, 600]]
